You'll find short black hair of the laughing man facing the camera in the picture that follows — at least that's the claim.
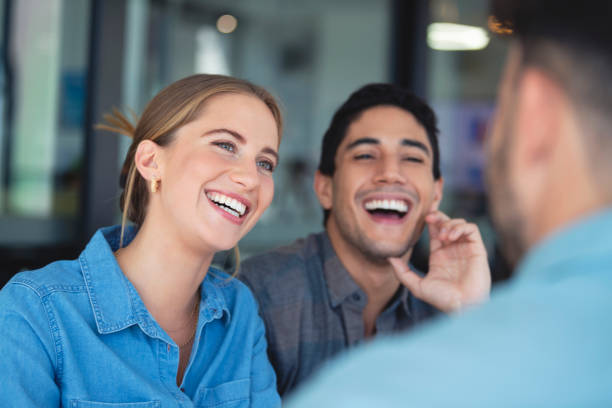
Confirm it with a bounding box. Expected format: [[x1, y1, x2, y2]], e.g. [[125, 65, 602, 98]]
[[319, 84, 441, 223]]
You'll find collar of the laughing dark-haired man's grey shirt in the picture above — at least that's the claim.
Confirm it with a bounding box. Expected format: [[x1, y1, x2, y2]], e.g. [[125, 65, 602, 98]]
[[321, 231, 411, 316]]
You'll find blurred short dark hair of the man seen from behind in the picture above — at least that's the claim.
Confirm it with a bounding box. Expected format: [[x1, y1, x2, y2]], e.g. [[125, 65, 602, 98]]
[[492, 0, 612, 196]]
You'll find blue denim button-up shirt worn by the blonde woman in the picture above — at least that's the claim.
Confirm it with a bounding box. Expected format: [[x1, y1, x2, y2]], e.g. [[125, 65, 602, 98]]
[[0, 227, 280, 408]]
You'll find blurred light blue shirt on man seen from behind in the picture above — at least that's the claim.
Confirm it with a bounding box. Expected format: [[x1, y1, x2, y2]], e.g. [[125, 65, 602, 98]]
[[288, 209, 612, 408]]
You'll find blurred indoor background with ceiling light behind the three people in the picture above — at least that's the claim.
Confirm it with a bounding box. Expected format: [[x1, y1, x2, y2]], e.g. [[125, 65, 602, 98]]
[[0, 0, 510, 286]]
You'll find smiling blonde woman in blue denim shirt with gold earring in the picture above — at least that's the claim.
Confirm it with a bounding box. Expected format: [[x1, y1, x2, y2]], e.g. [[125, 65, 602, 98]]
[[0, 75, 282, 407]]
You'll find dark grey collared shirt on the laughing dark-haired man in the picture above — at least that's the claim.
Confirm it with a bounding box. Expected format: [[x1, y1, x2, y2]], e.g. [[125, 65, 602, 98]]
[[238, 232, 436, 395]]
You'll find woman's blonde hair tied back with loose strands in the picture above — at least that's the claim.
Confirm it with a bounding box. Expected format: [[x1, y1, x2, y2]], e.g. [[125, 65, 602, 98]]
[[97, 74, 283, 250]]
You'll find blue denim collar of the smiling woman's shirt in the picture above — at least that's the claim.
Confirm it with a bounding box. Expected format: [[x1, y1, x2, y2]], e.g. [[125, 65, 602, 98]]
[[79, 226, 231, 338]]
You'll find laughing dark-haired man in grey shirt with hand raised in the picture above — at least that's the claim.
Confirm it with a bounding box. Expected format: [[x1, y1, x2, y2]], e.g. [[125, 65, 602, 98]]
[[239, 84, 491, 396]]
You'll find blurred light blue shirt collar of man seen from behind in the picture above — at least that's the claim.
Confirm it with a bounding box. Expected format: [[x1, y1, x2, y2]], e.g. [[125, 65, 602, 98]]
[[517, 207, 612, 278]]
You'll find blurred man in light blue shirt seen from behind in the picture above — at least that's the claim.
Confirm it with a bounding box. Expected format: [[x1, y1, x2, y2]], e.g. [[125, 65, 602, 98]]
[[289, 0, 612, 408]]
